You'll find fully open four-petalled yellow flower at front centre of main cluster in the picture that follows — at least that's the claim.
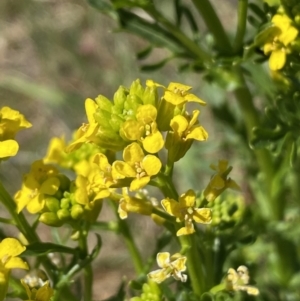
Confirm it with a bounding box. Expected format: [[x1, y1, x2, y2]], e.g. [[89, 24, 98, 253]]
[[112, 142, 162, 191]]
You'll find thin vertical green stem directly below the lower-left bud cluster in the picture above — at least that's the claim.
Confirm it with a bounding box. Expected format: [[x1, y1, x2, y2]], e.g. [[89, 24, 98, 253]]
[[78, 222, 93, 301]]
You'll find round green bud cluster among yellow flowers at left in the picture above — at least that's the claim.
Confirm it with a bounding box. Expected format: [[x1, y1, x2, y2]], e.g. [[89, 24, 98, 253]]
[[39, 183, 85, 227]]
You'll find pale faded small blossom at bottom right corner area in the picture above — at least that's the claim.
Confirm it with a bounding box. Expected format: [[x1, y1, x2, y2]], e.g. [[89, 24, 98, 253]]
[[226, 265, 259, 296]]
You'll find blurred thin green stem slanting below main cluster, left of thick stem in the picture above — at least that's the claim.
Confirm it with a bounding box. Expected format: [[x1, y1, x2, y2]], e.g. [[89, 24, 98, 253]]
[[110, 201, 144, 274]]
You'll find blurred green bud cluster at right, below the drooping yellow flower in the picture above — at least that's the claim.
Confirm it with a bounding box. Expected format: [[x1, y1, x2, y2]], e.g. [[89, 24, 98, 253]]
[[208, 193, 245, 227]]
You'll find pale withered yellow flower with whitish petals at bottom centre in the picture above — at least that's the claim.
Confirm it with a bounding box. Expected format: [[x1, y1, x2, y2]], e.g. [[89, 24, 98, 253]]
[[147, 252, 187, 283]]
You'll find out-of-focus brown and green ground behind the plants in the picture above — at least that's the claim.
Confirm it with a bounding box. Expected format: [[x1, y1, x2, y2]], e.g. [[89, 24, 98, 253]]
[[0, 0, 243, 300]]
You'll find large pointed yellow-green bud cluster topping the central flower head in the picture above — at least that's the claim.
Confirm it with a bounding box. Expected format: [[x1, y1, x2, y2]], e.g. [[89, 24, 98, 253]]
[[94, 79, 158, 151]]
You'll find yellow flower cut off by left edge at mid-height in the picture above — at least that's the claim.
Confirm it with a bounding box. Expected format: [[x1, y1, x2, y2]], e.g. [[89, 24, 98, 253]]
[[0, 107, 32, 159]]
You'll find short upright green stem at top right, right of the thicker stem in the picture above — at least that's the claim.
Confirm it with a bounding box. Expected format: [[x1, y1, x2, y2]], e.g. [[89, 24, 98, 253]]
[[233, 0, 248, 53]]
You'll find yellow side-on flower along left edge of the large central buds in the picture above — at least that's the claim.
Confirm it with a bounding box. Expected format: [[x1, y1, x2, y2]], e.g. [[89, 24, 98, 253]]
[[66, 98, 99, 152]]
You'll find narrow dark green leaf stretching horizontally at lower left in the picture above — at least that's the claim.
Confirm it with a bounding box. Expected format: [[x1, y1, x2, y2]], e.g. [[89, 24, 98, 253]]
[[22, 242, 78, 256]]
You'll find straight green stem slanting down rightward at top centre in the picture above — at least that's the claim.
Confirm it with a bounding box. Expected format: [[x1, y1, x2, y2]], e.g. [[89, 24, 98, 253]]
[[147, 8, 211, 62]]
